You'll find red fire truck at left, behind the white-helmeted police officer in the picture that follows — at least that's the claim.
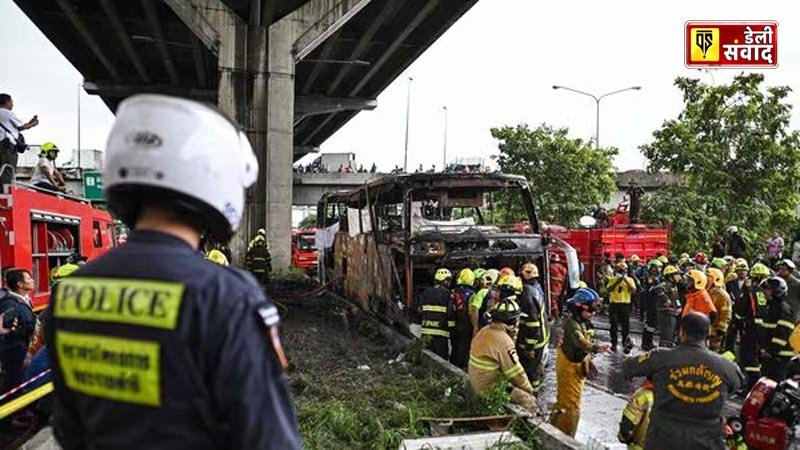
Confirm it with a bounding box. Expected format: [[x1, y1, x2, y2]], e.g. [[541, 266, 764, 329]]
[[0, 184, 116, 311]]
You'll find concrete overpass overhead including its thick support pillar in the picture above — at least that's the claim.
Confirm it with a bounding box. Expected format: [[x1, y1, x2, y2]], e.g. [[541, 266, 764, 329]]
[[14, 0, 477, 266]]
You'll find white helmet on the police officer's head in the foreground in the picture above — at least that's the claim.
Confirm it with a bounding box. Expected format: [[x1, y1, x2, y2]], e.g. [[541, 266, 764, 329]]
[[103, 94, 258, 242]]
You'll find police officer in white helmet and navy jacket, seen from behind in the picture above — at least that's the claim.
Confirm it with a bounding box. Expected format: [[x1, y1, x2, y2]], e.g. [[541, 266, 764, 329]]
[[46, 95, 300, 450]]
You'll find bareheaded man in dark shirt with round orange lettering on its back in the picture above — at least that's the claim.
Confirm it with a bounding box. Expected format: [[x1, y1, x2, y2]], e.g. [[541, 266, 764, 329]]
[[622, 312, 743, 450]]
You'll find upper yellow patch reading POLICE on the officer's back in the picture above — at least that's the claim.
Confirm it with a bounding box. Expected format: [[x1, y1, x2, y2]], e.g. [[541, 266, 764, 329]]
[[53, 277, 186, 330]]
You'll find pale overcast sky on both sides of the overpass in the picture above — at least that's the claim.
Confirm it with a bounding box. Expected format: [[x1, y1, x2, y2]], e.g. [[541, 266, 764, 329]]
[[0, 0, 800, 170]]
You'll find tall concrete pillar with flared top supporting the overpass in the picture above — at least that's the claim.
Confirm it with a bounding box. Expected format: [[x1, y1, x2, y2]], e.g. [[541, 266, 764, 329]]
[[170, 0, 370, 269]]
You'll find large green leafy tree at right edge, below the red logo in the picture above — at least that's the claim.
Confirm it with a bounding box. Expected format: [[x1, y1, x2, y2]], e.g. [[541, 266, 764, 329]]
[[640, 74, 800, 252]]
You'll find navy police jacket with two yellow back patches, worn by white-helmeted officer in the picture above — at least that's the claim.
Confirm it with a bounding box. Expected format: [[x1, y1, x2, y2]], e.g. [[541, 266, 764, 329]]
[[45, 231, 300, 450]]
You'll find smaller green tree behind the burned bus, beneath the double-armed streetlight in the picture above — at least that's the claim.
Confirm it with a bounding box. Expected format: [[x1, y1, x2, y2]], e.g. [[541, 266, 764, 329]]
[[491, 124, 617, 226]]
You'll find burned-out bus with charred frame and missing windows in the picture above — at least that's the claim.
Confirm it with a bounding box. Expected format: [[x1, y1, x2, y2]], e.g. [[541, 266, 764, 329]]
[[316, 173, 578, 326]]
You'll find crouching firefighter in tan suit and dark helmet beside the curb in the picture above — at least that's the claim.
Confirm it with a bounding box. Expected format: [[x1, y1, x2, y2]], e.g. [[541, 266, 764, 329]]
[[468, 298, 539, 413]]
